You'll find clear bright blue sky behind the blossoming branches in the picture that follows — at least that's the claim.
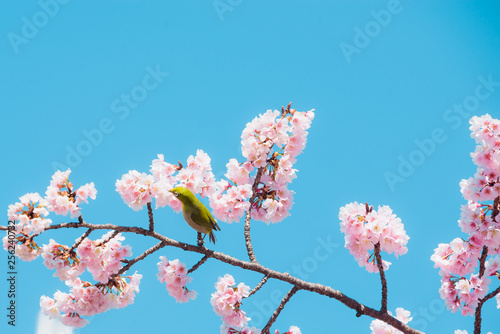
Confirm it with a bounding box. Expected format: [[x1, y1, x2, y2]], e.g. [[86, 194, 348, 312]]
[[0, 0, 500, 333]]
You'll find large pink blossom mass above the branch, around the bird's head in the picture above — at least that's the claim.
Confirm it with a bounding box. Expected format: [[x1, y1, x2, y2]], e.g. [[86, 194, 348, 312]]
[[116, 108, 314, 227]]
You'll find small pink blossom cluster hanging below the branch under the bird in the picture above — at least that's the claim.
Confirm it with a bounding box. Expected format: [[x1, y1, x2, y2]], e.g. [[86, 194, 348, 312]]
[[156, 256, 197, 303]]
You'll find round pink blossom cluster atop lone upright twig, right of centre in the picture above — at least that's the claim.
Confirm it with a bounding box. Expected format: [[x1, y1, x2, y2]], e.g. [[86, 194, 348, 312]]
[[339, 202, 409, 272]]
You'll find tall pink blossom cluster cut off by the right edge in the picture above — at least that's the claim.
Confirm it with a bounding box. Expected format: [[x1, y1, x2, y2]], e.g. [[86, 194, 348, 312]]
[[431, 114, 500, 315]]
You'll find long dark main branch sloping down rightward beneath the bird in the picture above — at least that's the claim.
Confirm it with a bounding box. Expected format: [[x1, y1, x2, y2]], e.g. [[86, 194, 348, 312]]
[[0, 222, 423, 334]]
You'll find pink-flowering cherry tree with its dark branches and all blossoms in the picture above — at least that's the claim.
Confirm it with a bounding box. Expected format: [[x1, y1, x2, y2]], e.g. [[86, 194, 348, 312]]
[[0, 104, 500, 334]]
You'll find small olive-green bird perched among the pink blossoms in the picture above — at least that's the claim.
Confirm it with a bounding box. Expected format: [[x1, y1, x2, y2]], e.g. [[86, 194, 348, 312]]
[[169, 187, 220, 244]]
